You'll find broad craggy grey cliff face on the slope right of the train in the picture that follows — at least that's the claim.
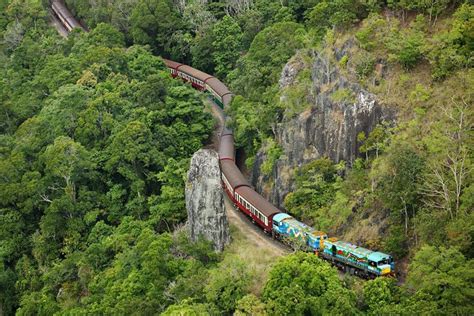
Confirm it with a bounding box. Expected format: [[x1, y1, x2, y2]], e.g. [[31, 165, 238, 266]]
[[252, 42, 394, 207]]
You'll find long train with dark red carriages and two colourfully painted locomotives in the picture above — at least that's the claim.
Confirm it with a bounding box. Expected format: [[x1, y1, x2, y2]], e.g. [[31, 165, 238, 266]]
[[51, 0, 395, 278]]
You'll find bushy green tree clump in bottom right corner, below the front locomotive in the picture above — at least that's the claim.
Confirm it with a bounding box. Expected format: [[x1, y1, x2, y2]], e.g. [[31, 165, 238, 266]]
[[364, 246, 474, 315]]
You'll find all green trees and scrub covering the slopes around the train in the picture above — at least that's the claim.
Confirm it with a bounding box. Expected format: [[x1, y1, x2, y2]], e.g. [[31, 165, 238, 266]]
[[0, 0, 474, 315]]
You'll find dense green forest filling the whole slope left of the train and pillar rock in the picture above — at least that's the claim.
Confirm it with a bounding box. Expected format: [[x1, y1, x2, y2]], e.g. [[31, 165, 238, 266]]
[[0, 2, 216, 315]]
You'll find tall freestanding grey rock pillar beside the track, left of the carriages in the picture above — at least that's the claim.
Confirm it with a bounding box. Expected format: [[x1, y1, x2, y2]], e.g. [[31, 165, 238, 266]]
[[186, 149, 230, 251]]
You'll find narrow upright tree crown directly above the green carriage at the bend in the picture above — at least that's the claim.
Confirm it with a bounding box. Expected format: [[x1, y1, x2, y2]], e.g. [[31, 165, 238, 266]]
[[212, 15, 242, 78]]
